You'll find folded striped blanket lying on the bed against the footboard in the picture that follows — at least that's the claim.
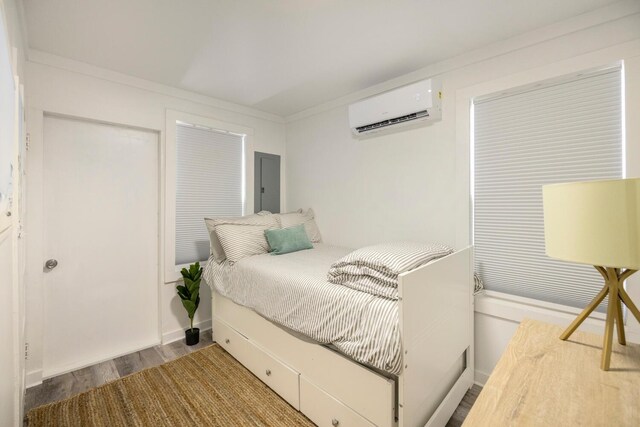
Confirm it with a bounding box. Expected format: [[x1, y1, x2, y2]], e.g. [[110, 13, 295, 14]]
[[327, 242, 453, 300]]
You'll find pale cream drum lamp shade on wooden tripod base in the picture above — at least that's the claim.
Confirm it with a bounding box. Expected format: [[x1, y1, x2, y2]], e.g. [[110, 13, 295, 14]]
[[542, 178, 640, 270]]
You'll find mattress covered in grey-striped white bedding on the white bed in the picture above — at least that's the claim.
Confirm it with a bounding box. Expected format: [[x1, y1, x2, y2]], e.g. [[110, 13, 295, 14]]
[[203, 243, 402, 375]]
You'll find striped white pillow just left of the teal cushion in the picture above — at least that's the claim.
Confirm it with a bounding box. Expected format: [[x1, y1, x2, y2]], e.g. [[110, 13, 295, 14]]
[[215, 224, 277, 264]]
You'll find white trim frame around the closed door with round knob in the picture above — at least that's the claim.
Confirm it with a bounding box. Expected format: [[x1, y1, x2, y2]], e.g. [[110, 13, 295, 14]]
[[25, 108, 165, 387]]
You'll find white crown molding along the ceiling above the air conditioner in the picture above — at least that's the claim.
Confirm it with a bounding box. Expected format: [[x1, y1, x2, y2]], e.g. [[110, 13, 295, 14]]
[[285, 0, 640, 123]]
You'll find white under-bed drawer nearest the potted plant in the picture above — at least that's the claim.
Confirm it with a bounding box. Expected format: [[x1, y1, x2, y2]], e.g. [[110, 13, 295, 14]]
[[214, 319, 300, 409]]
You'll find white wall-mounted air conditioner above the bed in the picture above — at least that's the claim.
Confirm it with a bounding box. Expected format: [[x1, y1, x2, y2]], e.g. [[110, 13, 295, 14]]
[[349, 79, 442, 137]]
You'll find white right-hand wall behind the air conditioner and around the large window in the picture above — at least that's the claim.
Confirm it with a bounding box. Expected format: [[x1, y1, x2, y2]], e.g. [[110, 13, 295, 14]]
[[287, 2, 640, 381]]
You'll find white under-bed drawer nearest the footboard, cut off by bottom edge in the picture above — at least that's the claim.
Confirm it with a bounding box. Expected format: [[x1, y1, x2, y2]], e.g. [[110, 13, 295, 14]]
[[300, 376, 374, 427]]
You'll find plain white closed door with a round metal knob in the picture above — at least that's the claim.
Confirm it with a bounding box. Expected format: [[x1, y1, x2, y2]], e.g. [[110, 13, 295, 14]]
[[42, 116, 160, 377]]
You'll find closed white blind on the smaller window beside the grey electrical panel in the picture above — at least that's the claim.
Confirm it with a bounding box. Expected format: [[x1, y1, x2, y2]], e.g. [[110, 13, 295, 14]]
[[175, 124, 244, 265]]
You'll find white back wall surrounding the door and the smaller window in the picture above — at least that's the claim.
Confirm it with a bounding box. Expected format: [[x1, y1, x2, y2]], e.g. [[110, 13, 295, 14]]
[[26, 55, 286, 384]]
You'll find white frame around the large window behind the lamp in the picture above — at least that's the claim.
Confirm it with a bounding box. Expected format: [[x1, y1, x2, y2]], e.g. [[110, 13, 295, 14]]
[[452, 57, 640, 314]]
